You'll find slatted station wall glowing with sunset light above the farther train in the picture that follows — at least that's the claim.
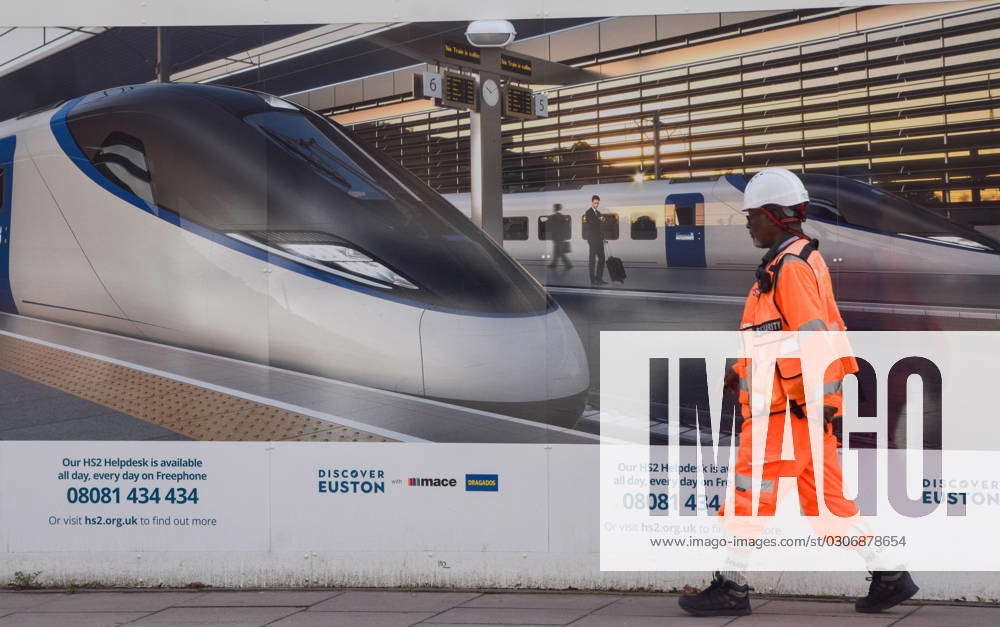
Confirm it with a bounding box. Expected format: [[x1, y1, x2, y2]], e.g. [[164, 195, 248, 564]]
[[342, 8, 1000, 221]]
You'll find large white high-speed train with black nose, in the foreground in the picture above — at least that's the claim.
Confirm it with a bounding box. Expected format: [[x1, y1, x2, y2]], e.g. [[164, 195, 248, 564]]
[[0, 84, 589, 425]]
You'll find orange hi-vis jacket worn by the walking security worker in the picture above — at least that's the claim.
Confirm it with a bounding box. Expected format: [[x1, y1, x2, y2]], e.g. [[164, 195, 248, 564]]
[[734, 237, 858, 418]]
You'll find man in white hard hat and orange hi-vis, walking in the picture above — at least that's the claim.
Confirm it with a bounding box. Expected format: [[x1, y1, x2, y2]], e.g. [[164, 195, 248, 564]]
[[680, 168, 918, 616]]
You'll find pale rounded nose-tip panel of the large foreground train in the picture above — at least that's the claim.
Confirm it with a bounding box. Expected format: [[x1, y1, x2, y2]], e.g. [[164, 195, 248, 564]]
[[420, 308, 590, 427]]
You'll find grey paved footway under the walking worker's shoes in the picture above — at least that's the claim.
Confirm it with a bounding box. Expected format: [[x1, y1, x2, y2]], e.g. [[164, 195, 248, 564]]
[[0, 590, 988, 627]]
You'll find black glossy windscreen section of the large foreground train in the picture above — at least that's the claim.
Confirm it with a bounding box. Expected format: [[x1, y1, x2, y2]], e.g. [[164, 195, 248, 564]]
[[67, 84, 552, 314]]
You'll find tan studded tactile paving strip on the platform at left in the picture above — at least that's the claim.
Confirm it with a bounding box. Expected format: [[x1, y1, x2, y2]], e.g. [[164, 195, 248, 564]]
[[0, 335, 393, 442]]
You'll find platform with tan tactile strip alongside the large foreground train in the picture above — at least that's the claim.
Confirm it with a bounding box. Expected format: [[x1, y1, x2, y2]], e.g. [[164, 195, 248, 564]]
[[0, 314, 597, 444]]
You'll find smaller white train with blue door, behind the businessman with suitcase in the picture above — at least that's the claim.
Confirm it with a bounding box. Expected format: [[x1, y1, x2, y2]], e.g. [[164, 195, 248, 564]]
[[445, 174, 1000, 280]]
